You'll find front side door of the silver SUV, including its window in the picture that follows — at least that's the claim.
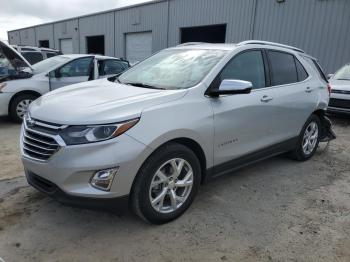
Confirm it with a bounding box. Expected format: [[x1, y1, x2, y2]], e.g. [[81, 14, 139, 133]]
[[210, 50, 276, 166]]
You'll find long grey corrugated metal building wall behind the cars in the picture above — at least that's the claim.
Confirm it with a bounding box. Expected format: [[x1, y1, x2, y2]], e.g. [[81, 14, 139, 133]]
[[9, 0, 350, 73]]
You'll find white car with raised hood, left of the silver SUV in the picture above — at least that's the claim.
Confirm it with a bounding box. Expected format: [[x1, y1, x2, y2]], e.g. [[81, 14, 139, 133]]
[[0, 42, 129, 122]]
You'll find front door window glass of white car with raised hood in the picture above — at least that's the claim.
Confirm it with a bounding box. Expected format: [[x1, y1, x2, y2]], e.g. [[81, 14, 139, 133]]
[[60, 57, 92, 77]]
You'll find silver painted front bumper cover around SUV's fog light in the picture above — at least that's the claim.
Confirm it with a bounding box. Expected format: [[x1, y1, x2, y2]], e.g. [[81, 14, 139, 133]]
[[20, 123, 151, 202]]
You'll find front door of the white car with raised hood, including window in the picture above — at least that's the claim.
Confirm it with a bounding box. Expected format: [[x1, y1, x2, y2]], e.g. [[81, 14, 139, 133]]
[[50, 56, 94, 90]]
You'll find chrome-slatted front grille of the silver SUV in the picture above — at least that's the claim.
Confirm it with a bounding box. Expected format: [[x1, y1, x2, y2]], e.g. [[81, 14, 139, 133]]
[[22, 119, 66, 161]]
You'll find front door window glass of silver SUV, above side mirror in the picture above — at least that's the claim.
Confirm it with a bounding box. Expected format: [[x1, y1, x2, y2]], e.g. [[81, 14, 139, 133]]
[[219, 51, 265, 89]]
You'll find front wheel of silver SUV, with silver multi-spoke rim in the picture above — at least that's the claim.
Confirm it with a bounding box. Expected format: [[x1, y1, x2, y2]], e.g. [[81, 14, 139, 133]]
[[132, 143, 201, 224]]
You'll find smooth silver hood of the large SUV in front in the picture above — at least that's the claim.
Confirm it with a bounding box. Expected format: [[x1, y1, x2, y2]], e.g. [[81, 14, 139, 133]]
[[29, 79, 187, 125]]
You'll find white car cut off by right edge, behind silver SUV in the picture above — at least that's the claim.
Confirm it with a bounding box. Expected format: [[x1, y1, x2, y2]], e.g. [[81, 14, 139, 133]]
[[328, 64, 350, 114]]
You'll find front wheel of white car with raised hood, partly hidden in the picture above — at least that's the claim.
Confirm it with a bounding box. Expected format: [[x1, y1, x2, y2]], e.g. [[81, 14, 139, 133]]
[[9, 94, 38, 123]]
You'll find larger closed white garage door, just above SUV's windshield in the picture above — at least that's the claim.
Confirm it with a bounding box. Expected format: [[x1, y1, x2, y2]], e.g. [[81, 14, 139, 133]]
[[125, 32, 152, 64]]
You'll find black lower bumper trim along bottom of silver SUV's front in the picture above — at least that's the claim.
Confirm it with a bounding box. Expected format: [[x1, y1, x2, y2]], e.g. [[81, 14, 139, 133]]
[[25, 171, 129, 214]]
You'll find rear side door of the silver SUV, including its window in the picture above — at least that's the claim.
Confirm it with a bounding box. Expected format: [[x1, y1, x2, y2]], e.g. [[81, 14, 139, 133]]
[[266, 50, 316, 139]]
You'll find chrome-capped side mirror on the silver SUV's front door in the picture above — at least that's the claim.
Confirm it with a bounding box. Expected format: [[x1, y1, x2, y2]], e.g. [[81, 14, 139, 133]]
[[209, 79, 253, 96]]
